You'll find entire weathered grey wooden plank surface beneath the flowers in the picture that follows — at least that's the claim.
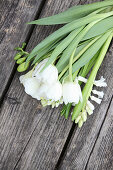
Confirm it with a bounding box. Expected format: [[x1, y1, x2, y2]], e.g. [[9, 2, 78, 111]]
[[0, 0, 113, 170]]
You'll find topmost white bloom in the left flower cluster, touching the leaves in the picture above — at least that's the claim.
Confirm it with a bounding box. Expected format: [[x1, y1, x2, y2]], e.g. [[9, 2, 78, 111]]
[[33, 59, 58, 84]]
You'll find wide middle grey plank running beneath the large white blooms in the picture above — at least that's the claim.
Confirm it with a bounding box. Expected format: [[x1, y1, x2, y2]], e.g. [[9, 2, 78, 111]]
[[0, 0, 81, 170]]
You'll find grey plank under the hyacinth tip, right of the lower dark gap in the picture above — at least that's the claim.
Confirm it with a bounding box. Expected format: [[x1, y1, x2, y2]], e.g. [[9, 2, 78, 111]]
[[59, 41, 113, 170]]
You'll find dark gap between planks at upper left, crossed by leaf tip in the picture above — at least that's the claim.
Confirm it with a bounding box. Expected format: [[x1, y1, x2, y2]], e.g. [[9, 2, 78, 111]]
[[0, 0, 46, 108]]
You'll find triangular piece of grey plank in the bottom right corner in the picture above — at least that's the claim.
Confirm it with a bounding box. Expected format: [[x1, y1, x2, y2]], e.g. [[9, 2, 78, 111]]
[[86, 99, 113, 170]]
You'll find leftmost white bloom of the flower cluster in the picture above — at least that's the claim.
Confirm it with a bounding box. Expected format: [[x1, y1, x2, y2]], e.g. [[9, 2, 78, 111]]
[[23, 77, 40, 100]]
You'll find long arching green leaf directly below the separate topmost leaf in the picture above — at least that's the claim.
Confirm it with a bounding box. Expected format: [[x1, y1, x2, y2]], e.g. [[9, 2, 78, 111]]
[[26, 14, 107, 62]]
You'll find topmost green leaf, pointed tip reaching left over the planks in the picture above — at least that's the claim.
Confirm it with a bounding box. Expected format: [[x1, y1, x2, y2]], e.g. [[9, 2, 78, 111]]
[[28, 0, 113, 25]]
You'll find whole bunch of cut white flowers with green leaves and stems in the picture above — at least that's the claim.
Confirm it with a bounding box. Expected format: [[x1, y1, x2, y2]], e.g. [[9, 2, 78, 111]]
[[14, 0, 113, 127]]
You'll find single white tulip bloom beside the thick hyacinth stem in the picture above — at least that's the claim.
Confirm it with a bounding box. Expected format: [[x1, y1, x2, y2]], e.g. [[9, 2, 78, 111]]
[[63, 82, 82, 104]]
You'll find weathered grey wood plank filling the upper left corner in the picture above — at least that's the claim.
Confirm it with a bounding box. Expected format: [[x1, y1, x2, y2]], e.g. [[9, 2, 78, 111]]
[[0, 0, 44, 99]]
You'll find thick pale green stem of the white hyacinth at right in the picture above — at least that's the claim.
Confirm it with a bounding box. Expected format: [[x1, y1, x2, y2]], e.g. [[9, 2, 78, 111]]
[[72, 32, 113, 121]]
